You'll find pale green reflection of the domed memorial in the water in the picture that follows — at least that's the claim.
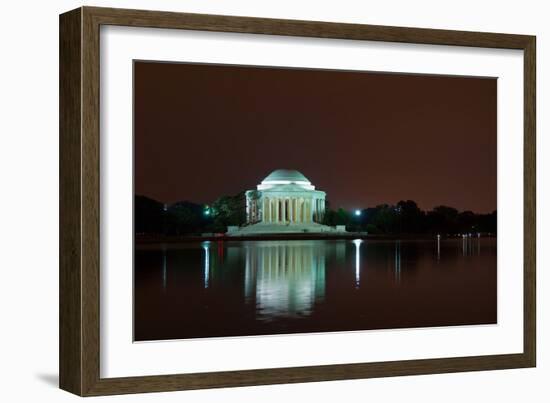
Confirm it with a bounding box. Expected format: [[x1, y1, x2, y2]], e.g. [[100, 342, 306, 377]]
[[245, 241, 326, 321]]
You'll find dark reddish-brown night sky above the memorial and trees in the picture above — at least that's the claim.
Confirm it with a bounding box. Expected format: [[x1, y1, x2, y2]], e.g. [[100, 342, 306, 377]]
[[134, 62, 497, 212]]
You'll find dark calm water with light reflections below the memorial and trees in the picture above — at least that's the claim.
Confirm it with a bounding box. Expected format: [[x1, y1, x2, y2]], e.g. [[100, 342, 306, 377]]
[[134, 238, 497, 341]]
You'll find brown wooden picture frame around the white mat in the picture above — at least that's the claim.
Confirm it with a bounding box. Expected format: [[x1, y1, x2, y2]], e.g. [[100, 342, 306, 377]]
[[59, 7, 536, 396]]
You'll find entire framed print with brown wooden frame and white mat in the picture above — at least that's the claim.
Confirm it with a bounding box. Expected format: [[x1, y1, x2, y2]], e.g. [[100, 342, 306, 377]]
[[60, 7, 536, 396]]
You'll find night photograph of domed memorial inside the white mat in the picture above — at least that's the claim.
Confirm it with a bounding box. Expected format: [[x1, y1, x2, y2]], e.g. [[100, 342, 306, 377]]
[[132, 59, 498, 342]]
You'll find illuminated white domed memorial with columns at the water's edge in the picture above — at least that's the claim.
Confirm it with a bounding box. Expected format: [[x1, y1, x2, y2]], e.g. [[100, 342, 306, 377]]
[[228, 169, 348, 235]]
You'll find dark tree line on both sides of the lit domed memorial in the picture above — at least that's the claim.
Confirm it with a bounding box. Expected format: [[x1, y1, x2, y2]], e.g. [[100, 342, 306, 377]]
[[134, 192, 497, 236]]
